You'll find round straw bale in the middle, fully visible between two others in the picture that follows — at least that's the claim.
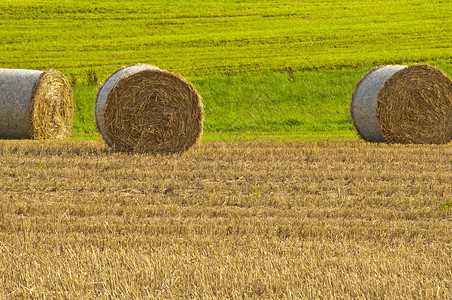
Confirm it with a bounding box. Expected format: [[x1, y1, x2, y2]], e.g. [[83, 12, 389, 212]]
[[95, 64, 203, 154]]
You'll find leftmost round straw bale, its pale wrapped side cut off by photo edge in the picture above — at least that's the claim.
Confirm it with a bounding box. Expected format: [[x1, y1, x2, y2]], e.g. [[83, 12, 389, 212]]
[[0, 69, 74, 139]]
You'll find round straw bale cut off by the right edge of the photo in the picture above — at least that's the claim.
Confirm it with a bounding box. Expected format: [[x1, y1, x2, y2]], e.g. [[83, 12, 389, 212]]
[[350, 64, 452, 144]]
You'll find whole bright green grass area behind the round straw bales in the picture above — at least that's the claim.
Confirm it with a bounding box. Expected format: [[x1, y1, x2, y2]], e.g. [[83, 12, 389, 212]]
[[0, 0, 452, 136]]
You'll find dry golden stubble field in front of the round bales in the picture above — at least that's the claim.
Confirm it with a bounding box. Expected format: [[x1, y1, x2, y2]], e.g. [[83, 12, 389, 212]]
[[0, 140, 452, 299]]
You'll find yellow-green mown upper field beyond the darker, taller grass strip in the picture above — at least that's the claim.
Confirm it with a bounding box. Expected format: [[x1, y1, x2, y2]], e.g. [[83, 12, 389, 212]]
[[0, 0, 452, 81]]
